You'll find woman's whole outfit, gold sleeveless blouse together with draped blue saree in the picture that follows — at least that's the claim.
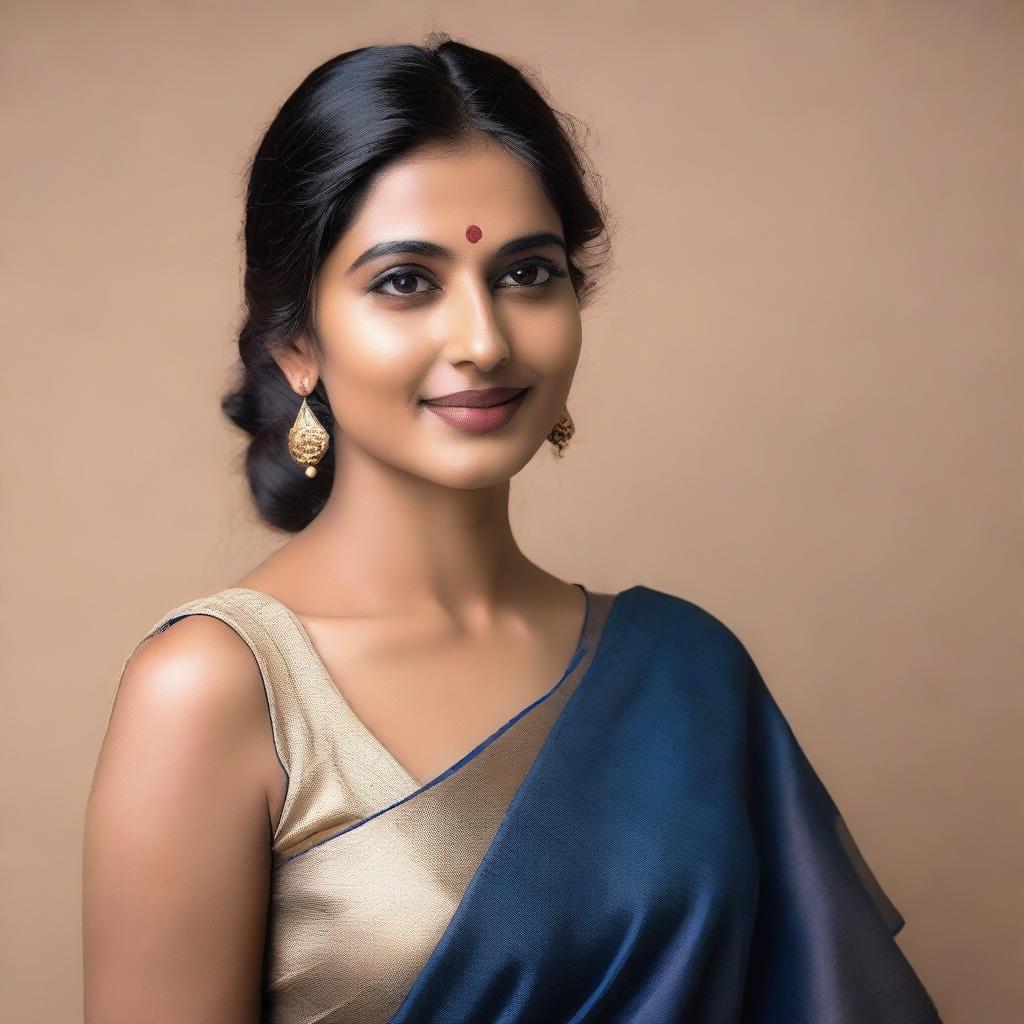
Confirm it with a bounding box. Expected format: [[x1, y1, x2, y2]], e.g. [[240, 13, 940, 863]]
[[119, 585, 941, 1024]]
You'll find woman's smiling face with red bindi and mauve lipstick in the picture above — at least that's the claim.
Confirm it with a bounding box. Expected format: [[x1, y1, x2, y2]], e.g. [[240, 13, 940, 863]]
[[293, 142, 582, 487]]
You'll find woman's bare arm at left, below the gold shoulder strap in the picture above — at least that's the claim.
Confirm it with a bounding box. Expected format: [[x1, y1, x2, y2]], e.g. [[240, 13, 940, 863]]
[[82, 615, 271, 1024]]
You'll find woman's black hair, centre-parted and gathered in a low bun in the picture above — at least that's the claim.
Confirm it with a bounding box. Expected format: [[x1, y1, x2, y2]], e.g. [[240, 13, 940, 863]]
[[221, 33, 609, 532]]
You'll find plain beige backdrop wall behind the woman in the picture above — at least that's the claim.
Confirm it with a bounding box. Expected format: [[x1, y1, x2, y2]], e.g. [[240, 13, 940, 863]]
[[0, 0, 1024, 1024]]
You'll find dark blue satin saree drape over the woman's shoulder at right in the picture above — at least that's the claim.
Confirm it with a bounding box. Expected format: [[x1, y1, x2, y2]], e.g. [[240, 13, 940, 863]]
[[382, 587, 938, 1024]]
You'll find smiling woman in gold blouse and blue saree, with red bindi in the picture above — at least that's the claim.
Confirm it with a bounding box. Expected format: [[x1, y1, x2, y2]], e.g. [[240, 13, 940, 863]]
[[84, 37, 938, 1024]]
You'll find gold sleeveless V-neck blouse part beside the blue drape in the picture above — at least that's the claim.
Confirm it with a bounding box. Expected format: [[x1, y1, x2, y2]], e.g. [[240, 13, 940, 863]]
[[111, 587, 615, 1024]]
